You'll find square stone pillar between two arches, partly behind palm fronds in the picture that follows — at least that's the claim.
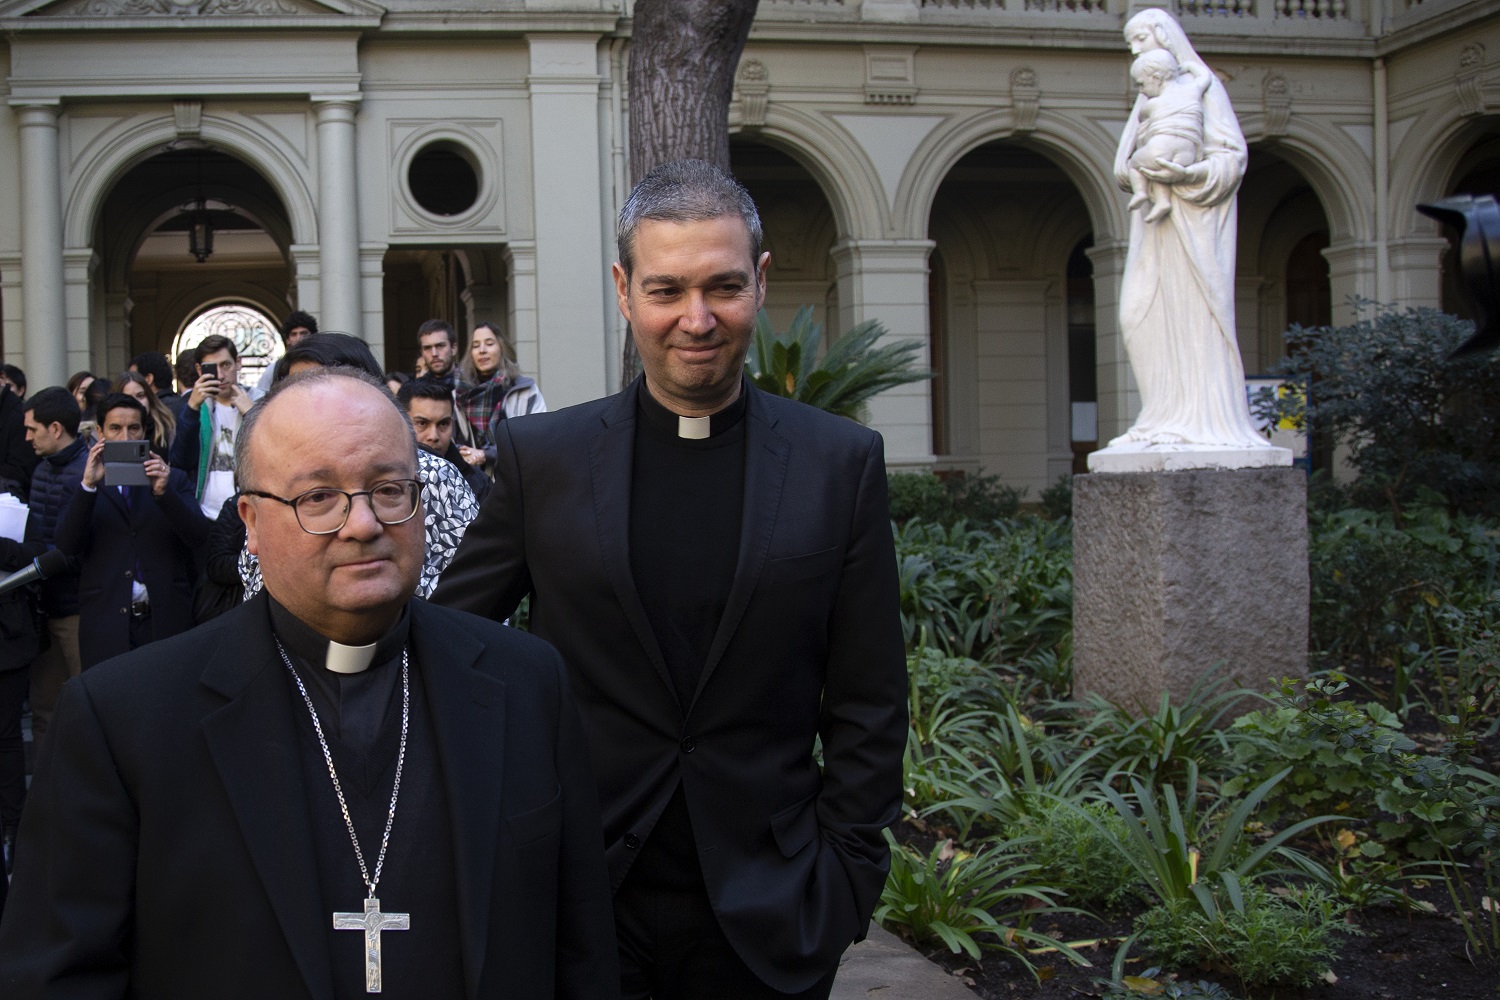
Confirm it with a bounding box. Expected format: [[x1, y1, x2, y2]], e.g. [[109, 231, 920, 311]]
[[831, 240, 936, 466]]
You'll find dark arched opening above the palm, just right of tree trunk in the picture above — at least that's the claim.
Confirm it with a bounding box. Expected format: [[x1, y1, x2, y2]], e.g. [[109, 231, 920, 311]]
[[729, 136, 842, 337]]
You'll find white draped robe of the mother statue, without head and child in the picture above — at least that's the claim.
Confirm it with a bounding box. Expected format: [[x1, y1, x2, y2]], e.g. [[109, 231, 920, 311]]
[[1110, 79, 1269, 448]]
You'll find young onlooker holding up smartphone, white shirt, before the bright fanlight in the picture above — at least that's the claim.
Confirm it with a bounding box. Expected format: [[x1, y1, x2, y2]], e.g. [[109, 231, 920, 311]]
[[171, 334, 261, 520]]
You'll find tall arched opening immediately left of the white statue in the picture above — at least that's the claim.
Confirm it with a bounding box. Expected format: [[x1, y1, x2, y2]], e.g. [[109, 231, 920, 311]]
[[927, 141, 1097, 498]]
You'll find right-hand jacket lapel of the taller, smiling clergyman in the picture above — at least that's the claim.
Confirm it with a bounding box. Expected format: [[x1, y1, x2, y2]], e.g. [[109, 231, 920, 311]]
[[693, 382, 792, 702]]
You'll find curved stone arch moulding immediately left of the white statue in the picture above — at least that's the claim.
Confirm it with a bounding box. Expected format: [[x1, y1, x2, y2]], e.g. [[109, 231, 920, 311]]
[[894, 109, 1128, 248]]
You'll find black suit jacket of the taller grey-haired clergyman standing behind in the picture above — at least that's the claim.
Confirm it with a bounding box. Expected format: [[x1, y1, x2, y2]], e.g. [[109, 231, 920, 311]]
[[434, 379, 906, 991]]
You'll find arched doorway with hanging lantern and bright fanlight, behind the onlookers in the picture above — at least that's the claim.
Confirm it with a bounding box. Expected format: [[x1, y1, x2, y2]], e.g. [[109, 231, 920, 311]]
[[90, 142, 296, 376]]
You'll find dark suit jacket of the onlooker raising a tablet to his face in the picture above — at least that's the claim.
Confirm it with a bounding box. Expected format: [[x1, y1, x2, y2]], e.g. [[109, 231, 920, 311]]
[[56, 469, 210, 667]]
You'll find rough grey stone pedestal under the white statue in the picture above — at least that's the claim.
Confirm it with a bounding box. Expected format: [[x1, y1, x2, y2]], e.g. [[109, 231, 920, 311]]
[[1073, 468, 1308, 709]]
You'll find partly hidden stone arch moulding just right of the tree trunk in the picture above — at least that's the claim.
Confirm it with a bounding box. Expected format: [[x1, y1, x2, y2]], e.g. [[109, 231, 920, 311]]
[[729, 102, 890, 240]]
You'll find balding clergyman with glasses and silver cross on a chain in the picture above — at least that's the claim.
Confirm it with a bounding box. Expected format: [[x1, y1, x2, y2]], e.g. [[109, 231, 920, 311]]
[[0, 369, 618, 1000]]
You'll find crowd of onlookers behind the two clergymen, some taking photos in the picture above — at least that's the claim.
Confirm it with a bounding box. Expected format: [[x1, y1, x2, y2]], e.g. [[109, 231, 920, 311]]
[[0, 312, 546, 906]]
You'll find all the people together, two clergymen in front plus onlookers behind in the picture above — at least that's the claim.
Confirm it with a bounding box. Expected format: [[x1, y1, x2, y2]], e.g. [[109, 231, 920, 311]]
[[0, 160, 908, 1000]]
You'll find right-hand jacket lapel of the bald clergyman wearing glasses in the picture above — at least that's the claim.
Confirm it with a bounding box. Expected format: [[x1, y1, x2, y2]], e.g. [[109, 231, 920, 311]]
[[411, 601, 510, 1000]]
